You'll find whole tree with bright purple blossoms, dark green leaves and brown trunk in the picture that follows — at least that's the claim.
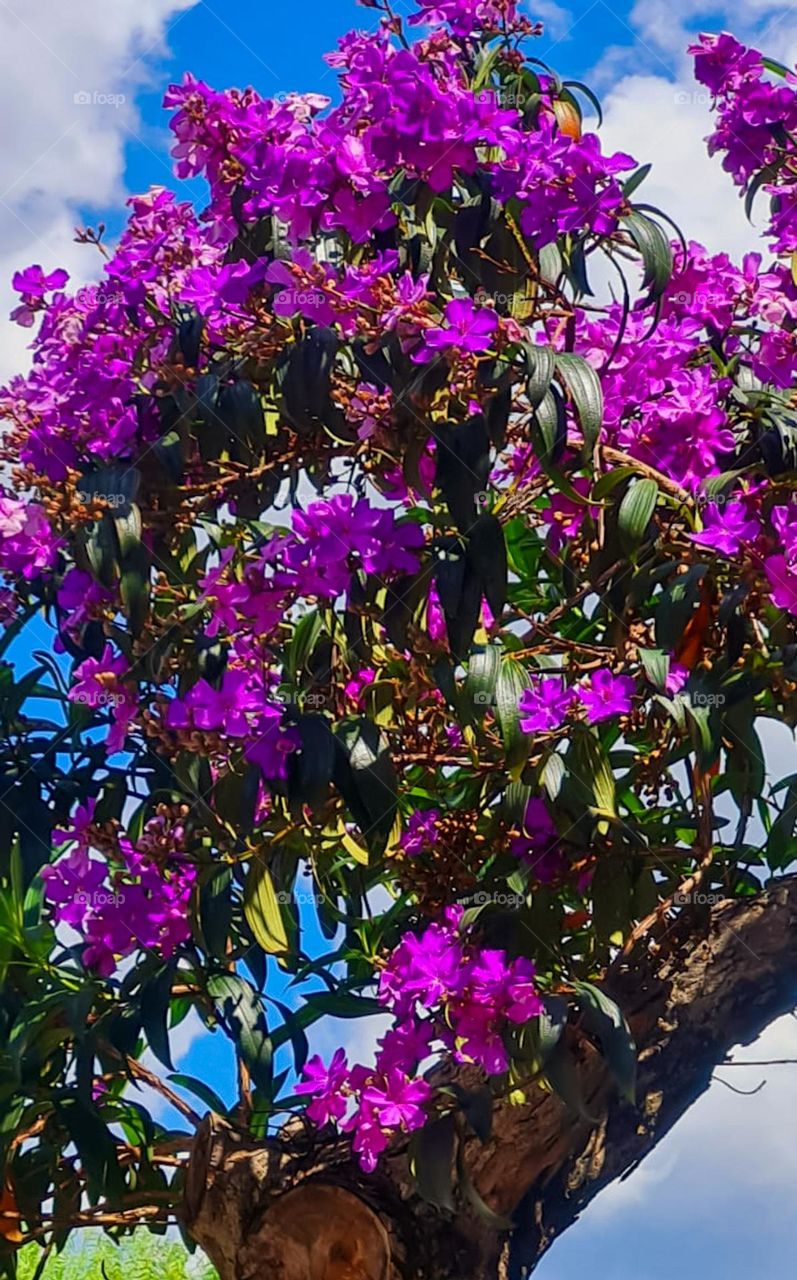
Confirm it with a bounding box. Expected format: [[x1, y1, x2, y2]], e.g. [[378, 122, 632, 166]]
[[0, 0, 797, 1280]]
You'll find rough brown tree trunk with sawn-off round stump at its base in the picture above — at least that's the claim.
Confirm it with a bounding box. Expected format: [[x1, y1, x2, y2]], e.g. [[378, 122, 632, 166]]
[[184, 877, 797, 1280]]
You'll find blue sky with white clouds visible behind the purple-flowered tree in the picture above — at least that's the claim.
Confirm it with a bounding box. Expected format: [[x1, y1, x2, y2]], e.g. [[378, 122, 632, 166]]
[[0, 0, 797, 1280]]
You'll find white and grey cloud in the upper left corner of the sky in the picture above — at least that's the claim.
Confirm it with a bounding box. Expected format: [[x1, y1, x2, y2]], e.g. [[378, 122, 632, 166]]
[[0, 0, 196, 379]]
